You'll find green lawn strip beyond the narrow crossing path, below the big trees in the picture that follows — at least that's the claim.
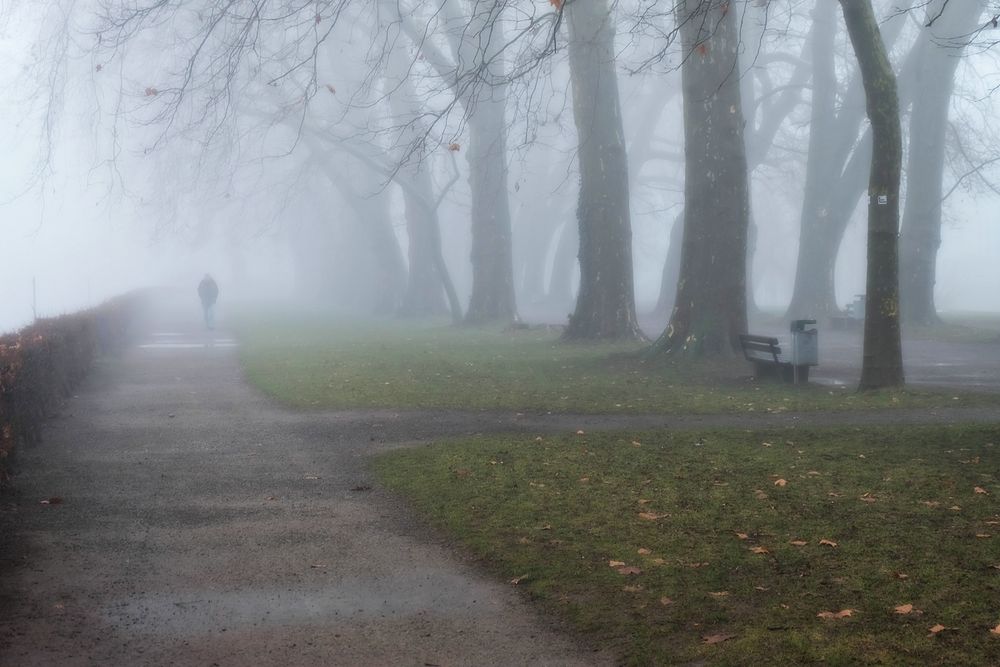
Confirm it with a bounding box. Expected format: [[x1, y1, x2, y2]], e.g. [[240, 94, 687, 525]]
[[229, 315, 1000, 414]]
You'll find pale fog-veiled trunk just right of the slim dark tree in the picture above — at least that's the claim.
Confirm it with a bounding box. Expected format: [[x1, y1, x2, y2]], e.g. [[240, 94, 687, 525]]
[[899, 0, 985, 324]]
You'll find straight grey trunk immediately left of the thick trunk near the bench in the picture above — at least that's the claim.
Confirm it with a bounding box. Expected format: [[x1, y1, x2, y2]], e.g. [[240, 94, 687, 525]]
[[565, 0, 642, 340]]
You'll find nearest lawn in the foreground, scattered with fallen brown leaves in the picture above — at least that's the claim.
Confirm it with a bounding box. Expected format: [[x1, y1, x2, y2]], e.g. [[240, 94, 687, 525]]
[[376, 426, 1000, 665]]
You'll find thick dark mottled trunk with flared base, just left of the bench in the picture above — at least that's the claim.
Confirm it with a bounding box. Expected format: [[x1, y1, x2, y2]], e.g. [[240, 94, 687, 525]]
[[656, 0, 750, 357]]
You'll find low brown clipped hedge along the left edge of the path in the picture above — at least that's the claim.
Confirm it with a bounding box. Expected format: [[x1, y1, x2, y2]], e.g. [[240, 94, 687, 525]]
[[0, 291, 148, 483]]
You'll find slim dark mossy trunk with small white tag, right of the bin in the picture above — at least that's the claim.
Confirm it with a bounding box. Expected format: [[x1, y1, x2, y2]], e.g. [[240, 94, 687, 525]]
[[840, 0, 903, 389]]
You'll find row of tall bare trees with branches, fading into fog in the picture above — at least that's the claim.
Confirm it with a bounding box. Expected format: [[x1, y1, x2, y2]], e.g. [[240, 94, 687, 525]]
[[5, 0, 1000, 386]]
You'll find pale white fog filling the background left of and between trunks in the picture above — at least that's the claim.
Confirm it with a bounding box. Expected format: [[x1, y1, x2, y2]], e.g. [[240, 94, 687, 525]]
[[0, 2, 1000, 335]]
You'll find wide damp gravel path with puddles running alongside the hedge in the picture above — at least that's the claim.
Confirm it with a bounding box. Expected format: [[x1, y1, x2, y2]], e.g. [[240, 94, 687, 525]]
[[0, 331, 609, 666]]
